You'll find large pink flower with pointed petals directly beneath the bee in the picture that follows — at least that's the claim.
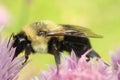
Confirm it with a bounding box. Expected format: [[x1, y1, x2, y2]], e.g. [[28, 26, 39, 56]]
[[36, 50, 112, 80]]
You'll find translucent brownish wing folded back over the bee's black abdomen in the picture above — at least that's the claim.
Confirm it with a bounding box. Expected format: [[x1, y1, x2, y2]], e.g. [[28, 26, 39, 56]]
[[47, 24, 103, 38]]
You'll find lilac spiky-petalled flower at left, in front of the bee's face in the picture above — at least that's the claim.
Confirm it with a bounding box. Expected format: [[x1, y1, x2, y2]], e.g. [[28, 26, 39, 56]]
[[0, 37, 25, 80]]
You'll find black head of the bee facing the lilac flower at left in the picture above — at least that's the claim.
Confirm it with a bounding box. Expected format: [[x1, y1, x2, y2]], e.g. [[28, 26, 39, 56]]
[[13, 32, 31, 57]]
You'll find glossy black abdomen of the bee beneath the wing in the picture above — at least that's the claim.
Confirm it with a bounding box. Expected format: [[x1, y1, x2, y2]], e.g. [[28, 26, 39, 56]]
[[61, 36, 91, 57]]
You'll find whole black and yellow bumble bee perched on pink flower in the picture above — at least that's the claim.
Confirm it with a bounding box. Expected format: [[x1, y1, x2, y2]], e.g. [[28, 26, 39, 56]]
[[12, 21, 102, 68]]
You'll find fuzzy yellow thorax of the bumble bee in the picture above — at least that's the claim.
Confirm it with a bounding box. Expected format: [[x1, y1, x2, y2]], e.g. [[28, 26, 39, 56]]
[[23, 21, 64, 52]]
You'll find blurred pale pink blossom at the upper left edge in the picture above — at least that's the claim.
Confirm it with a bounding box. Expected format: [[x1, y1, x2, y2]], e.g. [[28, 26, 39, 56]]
[[0, 6, 10, 31]]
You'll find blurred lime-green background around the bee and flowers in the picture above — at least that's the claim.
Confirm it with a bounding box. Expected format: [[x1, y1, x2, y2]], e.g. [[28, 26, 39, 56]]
[[0, 0, 120, 80]]
